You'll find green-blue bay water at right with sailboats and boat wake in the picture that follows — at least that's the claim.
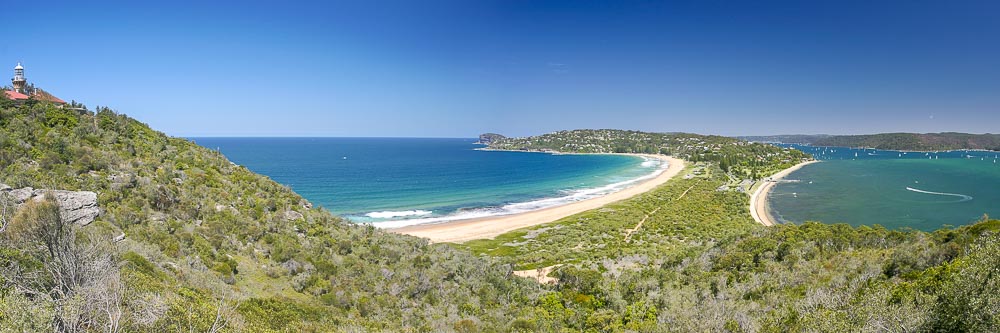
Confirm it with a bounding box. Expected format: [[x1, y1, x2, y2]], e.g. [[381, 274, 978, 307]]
[[768, 146, 1000, 231]]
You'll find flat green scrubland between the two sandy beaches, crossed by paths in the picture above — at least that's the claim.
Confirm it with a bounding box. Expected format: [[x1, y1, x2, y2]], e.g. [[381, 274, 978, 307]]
[[458, 165, 755, 270]]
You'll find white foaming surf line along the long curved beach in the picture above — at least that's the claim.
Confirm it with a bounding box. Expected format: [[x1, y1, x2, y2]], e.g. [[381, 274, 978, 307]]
[[366, 157, 669, 228]]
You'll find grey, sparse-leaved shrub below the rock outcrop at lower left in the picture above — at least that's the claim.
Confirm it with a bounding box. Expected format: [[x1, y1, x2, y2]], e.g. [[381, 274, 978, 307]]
[[0, 194, 125, 332]]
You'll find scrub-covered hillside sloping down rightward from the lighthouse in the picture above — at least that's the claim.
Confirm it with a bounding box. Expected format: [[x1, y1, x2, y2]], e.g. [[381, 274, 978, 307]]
[[0, 100, 542, 332]]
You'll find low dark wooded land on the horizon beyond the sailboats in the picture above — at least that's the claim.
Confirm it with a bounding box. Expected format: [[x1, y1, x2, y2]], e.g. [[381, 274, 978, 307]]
[[739, 132, 1000, 151]]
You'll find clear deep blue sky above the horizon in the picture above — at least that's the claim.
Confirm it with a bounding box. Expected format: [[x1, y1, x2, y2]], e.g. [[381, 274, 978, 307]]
[[0, 0, 1000, 137]]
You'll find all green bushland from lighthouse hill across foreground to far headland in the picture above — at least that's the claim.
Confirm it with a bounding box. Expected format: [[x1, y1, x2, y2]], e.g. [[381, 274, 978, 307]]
[[0, 100, 1000, 332]]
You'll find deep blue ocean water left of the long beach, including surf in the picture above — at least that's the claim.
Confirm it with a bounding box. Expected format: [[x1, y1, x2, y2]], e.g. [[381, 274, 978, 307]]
[[192, 138, 664, 227]]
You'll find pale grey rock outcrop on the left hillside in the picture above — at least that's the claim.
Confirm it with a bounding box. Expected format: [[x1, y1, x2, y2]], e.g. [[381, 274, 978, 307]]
[[0, 184, 101, 225]]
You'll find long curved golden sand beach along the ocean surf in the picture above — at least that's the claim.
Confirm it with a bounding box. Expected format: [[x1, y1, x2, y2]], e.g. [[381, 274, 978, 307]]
[[387, 154, 684, 243]]
